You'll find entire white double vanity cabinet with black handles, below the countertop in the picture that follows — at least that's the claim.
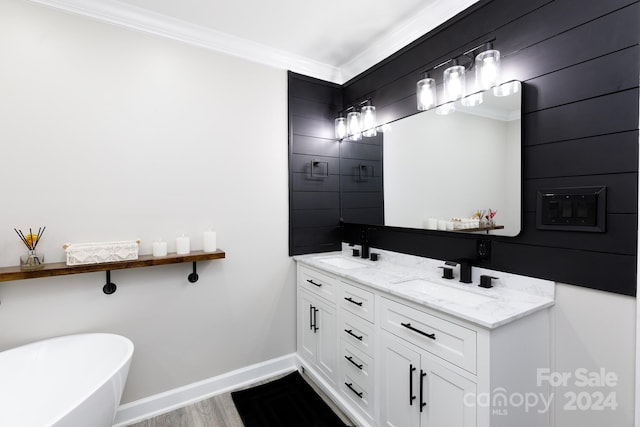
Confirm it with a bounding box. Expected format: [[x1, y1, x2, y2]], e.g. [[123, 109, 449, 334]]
[[297, 262, 552, 427]]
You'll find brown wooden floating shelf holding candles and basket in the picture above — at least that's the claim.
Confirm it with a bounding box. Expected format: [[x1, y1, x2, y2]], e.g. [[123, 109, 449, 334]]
[[0, 250, 225, 282]]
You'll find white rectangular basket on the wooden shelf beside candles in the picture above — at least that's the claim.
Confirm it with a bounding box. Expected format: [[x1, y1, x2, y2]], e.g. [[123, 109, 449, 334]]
[[63, 240, 140, 265]]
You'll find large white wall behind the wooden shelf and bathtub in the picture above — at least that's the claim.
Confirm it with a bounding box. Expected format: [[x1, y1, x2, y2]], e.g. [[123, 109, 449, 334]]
[[0, 0, 295, 403]]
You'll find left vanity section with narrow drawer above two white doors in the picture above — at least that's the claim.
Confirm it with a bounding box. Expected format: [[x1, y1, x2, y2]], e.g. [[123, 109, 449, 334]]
[[297, 267, 338, 385]]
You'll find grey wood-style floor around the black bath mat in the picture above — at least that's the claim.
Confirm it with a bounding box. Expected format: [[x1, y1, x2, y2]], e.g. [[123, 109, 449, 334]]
[[128, 374, 354, 427]]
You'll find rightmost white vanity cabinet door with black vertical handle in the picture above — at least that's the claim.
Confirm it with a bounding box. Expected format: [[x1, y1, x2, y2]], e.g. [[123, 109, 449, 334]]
[[418, 356, 476, 427]]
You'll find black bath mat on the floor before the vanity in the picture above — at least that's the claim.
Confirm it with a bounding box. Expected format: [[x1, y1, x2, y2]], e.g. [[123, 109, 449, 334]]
[[231, 371, 346, 427]]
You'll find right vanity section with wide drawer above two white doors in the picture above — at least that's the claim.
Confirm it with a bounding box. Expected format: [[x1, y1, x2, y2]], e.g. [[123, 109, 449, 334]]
[[380, 298, 476, 427]]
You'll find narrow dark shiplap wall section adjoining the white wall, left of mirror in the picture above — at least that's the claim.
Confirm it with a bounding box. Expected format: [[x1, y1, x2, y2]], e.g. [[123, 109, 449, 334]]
[[289, 72, 342, 255]]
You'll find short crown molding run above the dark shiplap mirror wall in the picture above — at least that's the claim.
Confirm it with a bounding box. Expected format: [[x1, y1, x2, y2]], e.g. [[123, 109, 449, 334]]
[[340, 0, 478, 84]]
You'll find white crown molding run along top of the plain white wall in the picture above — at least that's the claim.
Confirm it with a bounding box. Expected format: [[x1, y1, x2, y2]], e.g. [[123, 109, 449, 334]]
[[30, 0, 343, 83]]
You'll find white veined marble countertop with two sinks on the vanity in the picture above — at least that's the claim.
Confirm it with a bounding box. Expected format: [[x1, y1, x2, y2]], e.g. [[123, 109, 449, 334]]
[[294, 247, 555, 329]]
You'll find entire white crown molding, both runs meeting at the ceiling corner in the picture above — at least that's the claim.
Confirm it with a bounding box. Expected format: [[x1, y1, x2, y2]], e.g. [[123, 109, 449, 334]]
[[30, 0, 478, 84]]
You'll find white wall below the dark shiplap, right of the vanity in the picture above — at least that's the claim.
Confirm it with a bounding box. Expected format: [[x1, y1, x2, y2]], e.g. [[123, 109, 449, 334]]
[[551, 284, 636, 427]]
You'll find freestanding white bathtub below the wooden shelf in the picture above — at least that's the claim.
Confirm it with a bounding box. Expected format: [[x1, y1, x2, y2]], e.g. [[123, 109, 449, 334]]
[[0, 333, 133, 427]]
